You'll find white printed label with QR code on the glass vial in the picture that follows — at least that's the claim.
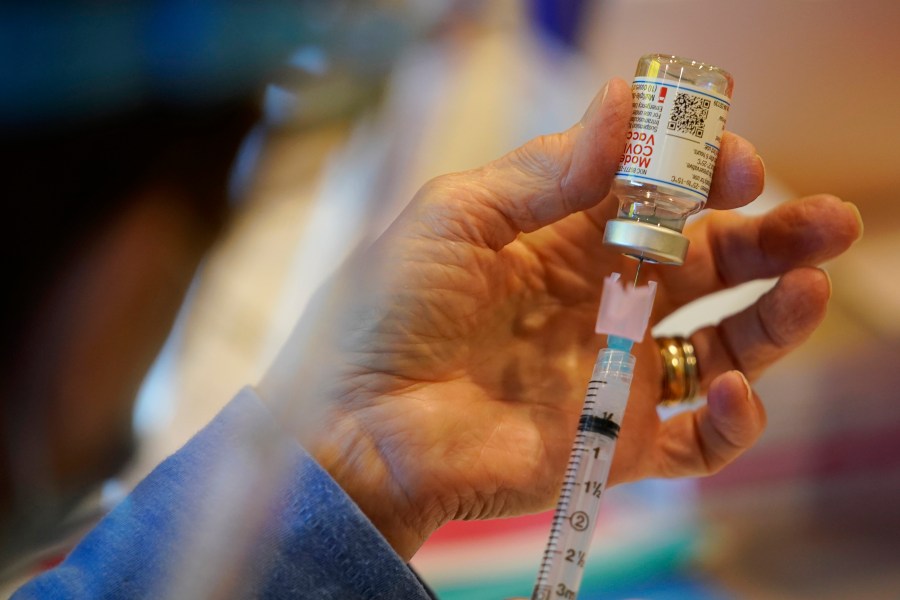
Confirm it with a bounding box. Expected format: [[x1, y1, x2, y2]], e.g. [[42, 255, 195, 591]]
[[616, 77, 731, 201]]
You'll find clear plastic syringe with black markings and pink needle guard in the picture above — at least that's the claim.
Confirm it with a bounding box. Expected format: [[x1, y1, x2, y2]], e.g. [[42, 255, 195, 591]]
[[531, 273, 656, 600]]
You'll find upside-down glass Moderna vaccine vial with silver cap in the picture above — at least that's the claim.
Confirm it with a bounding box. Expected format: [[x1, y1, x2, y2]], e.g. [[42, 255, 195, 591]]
[[603, 54, 734, 265]]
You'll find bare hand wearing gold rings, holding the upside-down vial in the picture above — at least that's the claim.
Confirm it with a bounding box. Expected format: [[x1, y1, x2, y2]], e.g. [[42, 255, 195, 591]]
[[260, 80, 860, 559]]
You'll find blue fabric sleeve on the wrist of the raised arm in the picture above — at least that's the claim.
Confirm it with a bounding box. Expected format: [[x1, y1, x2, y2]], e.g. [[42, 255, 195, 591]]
[[13, 388, 431, 600]]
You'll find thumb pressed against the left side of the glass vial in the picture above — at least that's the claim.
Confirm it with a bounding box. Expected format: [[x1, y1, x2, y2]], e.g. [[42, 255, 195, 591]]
[[412, 79, 631, 249]]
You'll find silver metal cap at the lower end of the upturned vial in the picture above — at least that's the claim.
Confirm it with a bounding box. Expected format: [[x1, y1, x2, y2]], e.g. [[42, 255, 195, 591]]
[[603, 219, 690, 265]]
